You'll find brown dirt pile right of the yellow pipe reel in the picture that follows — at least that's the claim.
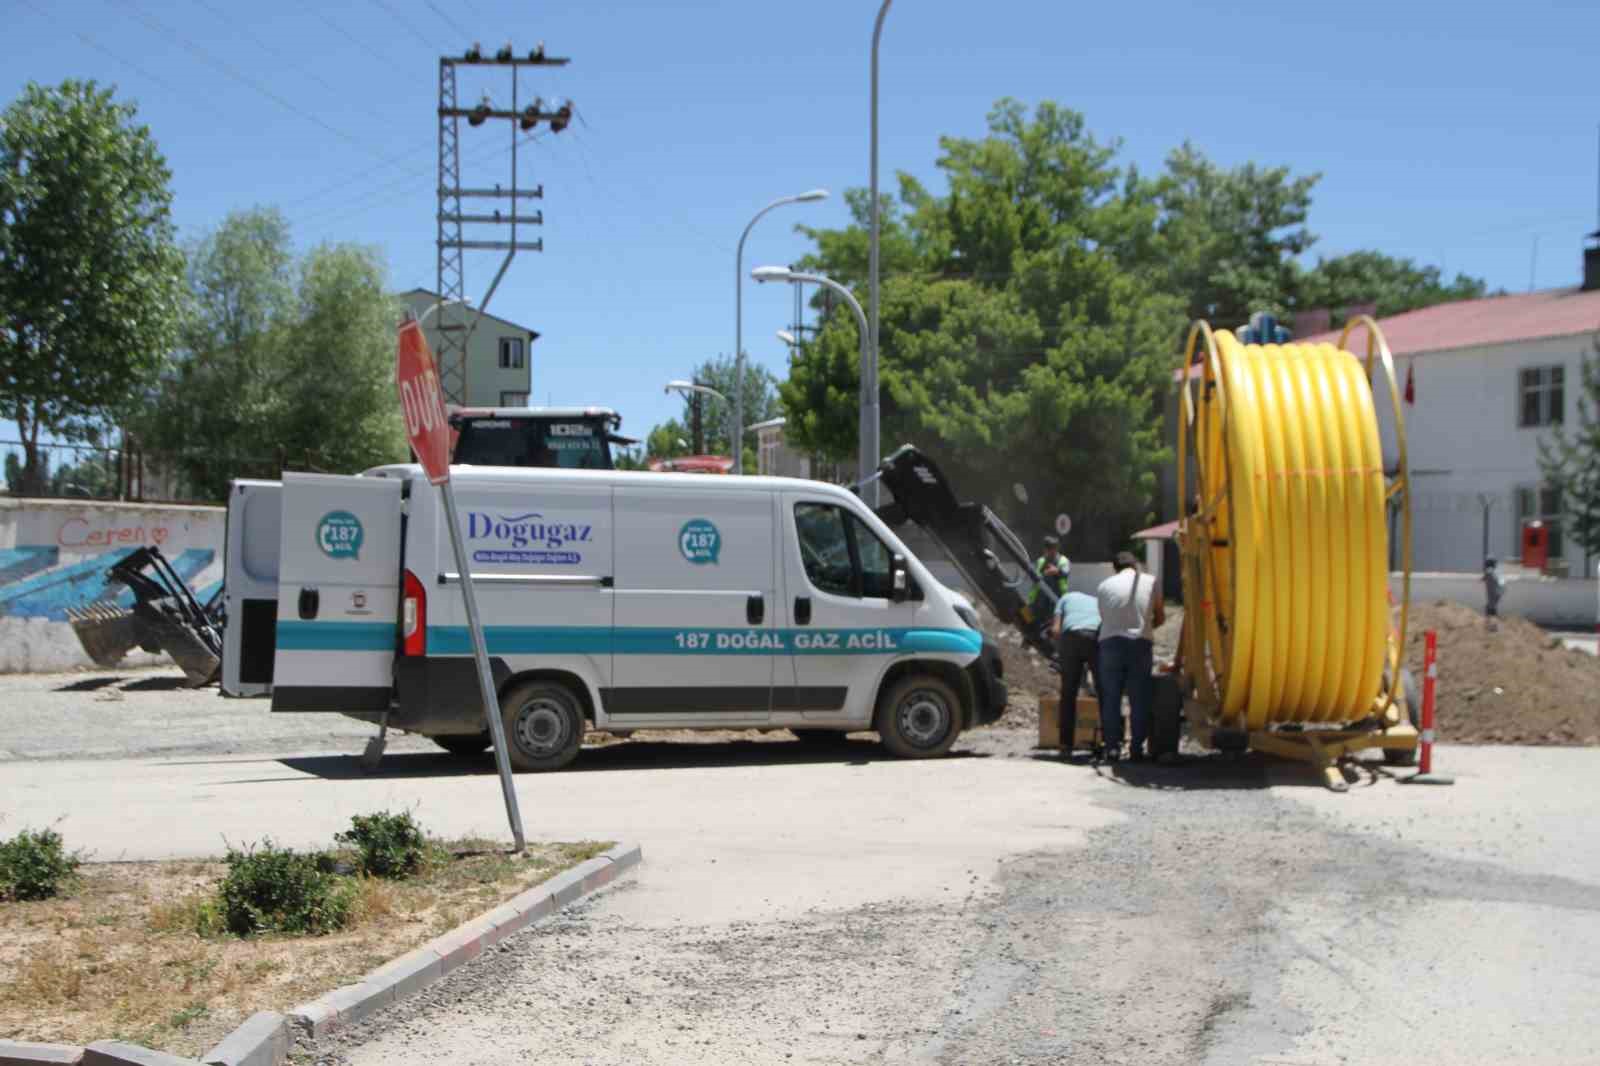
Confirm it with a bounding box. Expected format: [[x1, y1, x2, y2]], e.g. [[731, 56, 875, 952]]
[[1406, 602, 1600, 744]]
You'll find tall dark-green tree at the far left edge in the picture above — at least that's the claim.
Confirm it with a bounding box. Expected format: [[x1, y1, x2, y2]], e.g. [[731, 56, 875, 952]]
[[0, 80, 182, 491]]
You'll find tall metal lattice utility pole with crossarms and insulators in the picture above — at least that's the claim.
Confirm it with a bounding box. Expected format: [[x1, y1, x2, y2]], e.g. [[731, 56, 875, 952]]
[[435, 43, 573, 403]]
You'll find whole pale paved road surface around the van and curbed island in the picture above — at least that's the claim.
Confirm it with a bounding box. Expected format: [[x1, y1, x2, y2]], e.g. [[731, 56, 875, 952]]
[[0, 669, 1600, 1066]]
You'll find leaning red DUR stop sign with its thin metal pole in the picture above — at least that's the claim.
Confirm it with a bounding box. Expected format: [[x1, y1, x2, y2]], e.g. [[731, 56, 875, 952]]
[[395, 319, 528, 853]]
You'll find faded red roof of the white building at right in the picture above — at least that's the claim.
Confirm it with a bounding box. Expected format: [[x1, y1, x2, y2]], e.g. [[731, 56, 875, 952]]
[[1189, 288, 1600, 378]]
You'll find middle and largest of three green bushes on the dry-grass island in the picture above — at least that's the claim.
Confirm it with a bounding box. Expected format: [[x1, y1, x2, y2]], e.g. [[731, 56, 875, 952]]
[[218, 840, 357, 936]]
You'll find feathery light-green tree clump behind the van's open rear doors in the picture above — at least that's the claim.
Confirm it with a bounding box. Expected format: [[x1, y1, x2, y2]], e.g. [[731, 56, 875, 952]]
[[130, 208, 405, 498]]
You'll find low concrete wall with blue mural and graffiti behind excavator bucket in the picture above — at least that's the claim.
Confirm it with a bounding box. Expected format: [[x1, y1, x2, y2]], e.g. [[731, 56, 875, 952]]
[[0, 498, 226, 674]]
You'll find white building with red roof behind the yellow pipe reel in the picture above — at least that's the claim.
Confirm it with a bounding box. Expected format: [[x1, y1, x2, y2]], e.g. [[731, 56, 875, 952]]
[[1294, 275, 1600, 576]]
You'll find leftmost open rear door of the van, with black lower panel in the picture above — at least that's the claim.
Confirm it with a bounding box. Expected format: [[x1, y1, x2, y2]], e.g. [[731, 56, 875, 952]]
[[222, 480, 283, 696]]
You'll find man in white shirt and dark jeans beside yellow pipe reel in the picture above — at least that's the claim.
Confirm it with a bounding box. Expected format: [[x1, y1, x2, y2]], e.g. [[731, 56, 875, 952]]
[[1094, 552, 1166, 762]]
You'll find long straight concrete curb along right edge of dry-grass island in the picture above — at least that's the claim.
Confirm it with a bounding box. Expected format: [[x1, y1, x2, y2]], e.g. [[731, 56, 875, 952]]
[[281, 844, 643, 1037]]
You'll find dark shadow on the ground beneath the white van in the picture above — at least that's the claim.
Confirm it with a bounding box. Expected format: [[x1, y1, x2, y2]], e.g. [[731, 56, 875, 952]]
[[272, 739, 987, 784]]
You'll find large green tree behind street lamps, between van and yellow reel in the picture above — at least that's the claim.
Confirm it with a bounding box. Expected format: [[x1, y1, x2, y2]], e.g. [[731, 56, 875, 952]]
[[779, 101, 1182, 554]]
